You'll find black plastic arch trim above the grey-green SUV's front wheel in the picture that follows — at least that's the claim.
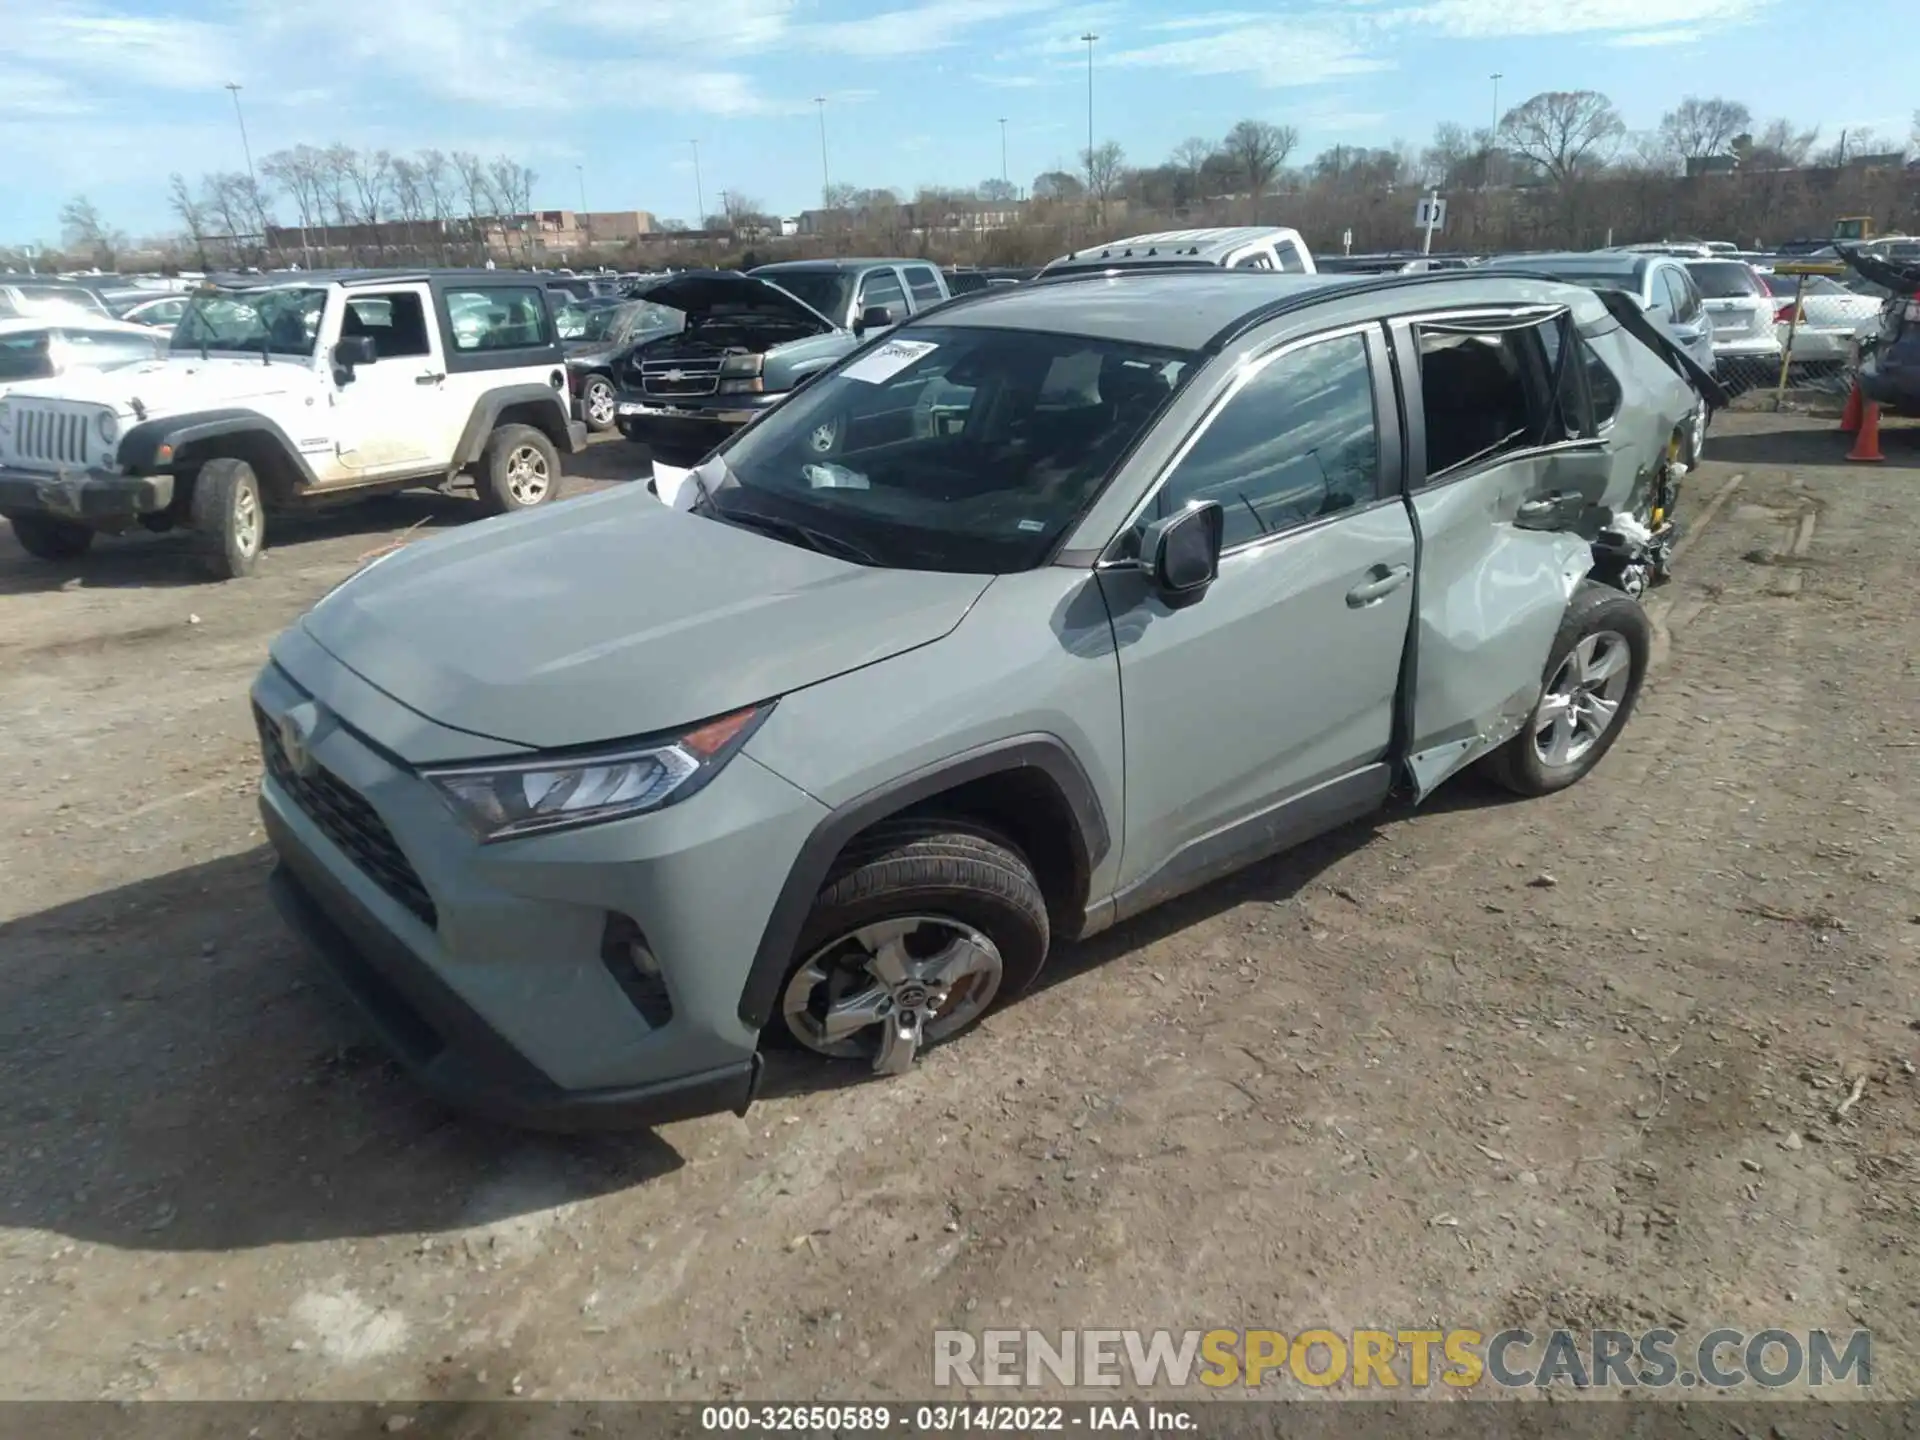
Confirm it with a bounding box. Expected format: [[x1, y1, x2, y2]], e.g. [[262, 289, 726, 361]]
[[739, 733, 1112, 1029]]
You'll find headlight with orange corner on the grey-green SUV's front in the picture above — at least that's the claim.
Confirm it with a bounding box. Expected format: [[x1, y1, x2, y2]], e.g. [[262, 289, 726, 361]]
[[424, 705, 774, 843]]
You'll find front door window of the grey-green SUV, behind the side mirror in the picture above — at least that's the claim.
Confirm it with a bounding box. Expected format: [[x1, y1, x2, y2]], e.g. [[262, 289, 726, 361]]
[[1148, 334, 1380, 549]]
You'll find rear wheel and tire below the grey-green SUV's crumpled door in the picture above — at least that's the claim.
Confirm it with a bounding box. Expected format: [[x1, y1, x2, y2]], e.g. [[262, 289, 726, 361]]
[[1486, 580, 1653, 795]]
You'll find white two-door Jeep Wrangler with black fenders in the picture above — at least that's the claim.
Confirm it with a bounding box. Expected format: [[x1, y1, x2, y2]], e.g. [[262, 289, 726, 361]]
[[0, 271, 586, 580]]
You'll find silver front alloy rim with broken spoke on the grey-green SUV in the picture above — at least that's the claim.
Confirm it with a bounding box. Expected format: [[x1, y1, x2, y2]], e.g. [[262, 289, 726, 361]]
[[781, 916, 1002, 1075]]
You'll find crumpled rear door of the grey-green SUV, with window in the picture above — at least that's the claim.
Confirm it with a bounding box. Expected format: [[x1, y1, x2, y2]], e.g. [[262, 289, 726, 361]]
[[1392, 305, 1617, 799]]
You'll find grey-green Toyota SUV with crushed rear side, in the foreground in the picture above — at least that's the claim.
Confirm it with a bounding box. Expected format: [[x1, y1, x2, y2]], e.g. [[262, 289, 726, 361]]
[[253, 269, 1716, 1127]]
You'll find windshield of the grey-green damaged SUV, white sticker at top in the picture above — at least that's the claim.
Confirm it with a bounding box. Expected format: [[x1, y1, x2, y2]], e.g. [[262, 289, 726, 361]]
[[695, 326, 1194, 574]]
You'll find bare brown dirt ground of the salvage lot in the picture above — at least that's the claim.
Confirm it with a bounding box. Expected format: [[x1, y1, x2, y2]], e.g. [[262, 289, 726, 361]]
[[0, 415, 1920, 1400]]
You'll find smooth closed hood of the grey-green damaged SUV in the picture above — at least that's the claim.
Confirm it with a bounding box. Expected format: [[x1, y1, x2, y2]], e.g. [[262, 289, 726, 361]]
[[301, 488, 993, 749]]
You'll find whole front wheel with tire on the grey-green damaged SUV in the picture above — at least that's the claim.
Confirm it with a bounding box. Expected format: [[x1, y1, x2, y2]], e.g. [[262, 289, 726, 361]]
[[770, 816, 1050, 1073]]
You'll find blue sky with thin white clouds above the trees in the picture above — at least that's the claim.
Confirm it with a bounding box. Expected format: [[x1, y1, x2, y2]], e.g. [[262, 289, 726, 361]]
[[0, 0, 1920, 244]]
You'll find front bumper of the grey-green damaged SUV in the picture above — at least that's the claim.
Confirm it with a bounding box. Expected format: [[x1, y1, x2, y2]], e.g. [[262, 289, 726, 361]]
[[253, 648, 824, 1129]]
